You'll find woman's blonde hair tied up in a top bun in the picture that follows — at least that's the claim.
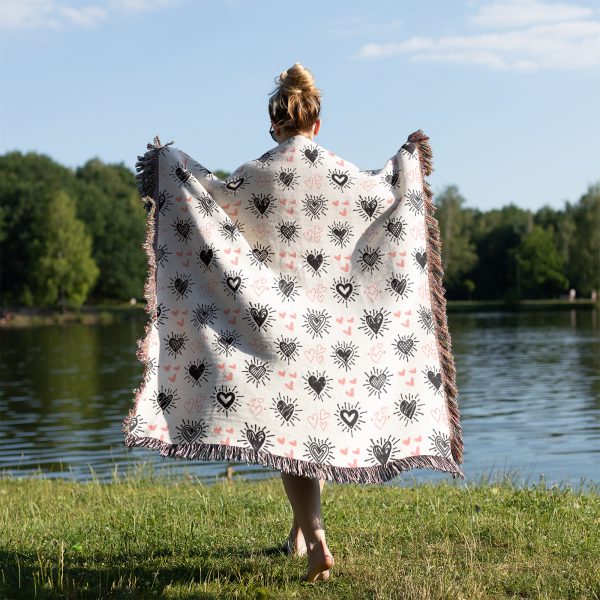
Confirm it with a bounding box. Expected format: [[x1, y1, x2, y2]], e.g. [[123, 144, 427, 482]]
[[269, 63, 321, 132]]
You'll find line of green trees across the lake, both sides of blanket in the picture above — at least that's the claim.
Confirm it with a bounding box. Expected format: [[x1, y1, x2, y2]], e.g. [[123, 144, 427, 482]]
[[0, 151, 600, 308]]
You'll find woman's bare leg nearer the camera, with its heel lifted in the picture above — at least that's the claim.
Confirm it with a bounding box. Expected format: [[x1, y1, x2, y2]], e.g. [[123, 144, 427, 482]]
[[281, 472, 333, 582]]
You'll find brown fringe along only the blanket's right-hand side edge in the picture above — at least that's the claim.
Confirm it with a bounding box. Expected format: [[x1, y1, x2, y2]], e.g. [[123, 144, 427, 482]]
[[408, 129, 464, 479]]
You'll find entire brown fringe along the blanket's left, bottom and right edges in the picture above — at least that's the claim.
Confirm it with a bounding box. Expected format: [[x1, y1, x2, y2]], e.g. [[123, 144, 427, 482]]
[[122, 129, 465, 484]]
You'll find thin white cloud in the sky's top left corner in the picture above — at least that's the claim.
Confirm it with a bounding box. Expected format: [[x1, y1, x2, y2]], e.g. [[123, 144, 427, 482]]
[[0, 0, 178, 29]]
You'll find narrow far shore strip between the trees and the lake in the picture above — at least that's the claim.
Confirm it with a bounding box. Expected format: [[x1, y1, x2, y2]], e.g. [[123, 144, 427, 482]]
[[0, 298, 600, 327]]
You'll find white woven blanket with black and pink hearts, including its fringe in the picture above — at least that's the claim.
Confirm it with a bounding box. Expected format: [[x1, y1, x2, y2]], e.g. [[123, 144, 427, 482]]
[[123, 130, 464, 483]]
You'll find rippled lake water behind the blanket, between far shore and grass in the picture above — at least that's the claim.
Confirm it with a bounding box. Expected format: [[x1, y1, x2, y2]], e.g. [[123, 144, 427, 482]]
[[0, 310, 600, 486]]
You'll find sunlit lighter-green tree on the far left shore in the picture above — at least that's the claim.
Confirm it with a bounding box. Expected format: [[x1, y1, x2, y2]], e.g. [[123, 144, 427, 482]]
[[30, 191, 100, 311]]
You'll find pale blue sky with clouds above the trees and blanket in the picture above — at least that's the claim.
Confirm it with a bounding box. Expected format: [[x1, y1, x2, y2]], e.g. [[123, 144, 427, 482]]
[[0, 0, 600, 210]]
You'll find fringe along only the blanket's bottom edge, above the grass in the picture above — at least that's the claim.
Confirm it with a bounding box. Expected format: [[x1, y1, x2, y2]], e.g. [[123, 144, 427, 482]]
[[125, 435, 464, 484]]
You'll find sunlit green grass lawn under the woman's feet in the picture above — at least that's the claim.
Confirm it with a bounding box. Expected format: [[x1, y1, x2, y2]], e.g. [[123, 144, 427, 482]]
[[0, 472, 600, 600]]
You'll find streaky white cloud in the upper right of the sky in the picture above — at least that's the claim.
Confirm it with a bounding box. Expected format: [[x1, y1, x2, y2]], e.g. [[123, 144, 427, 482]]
[[355, 0, 600, 71]]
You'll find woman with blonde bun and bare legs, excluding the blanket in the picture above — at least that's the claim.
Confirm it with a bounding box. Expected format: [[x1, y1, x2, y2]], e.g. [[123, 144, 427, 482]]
[[269, 63, 334, 581]]
